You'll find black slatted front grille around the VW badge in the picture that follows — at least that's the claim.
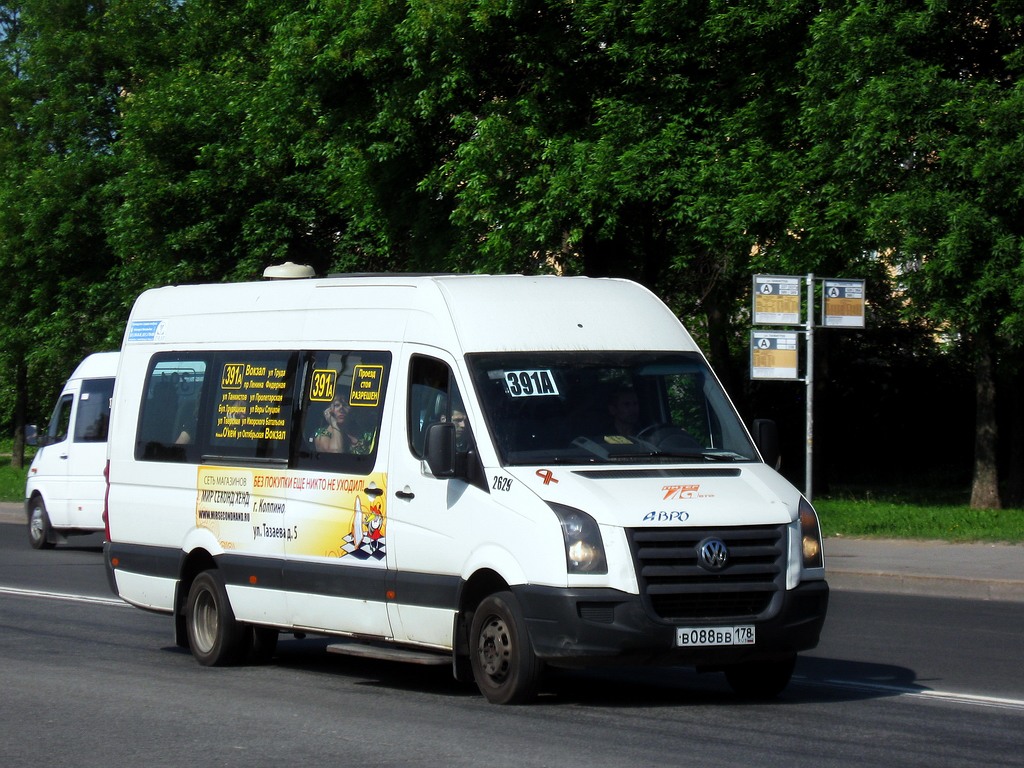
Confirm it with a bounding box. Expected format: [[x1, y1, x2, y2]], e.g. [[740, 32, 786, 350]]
[[628, 525, 786, 622]]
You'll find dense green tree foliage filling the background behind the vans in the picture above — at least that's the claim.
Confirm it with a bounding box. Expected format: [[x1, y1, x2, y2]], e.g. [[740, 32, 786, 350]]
[[0, 0, 1024, 507]]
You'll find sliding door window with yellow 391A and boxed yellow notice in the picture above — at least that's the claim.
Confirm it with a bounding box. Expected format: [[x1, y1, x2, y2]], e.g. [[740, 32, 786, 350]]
[[298, 350, 391, 474]]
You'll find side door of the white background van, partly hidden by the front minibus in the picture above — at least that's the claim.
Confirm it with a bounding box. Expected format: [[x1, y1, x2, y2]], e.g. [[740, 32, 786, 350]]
[[68, 378, 114, 529]]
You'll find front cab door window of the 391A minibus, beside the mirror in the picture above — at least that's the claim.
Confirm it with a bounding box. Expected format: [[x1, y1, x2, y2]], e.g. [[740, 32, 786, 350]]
[[408, 355, 472, 459]]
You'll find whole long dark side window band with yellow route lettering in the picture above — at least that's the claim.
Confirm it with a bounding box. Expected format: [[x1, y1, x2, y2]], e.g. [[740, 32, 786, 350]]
[[135, 350, 391, 474]]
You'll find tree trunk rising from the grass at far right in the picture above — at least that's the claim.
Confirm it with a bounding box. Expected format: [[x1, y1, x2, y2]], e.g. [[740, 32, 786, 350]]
[[970, 330, 1002, 509]]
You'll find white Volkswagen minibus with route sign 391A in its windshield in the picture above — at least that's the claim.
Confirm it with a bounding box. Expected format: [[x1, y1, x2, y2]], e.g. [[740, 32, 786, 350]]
[[105, 274, 828, 703]]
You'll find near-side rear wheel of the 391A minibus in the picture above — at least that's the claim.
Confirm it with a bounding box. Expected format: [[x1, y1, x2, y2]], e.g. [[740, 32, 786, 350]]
[[185, 569, 252, 667]]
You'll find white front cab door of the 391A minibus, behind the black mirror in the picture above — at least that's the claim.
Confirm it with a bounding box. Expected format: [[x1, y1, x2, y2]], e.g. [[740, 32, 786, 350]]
[[387, 350, 488, 647]]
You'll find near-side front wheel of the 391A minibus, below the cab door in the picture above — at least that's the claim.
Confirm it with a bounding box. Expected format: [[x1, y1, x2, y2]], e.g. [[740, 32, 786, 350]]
[[469, 592, 542, 705]]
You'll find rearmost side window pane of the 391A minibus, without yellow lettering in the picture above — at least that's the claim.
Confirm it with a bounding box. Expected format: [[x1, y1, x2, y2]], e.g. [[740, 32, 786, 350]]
[[135, 354, 208, 462]]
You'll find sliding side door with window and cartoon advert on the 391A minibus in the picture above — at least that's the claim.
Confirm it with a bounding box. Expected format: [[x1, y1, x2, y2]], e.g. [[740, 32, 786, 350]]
[[285, 348, 392, 638]]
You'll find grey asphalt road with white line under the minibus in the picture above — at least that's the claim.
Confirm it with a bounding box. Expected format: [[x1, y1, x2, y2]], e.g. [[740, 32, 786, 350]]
[[0, 524, 1024, 768]]
